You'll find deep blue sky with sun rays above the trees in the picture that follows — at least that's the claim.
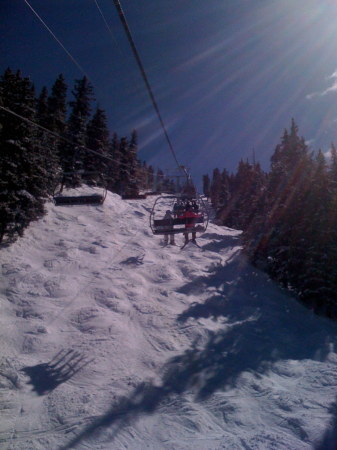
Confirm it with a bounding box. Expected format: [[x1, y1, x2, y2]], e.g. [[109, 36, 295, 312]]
[[0, 0, 337, 183]]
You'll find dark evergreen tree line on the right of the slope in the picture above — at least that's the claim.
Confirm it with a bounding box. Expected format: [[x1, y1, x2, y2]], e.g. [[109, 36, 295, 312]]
[[203, 120, 337, 318]]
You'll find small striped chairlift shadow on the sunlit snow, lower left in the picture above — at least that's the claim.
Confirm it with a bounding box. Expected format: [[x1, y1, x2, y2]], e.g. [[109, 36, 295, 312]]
[[21, 350, 92, 395]]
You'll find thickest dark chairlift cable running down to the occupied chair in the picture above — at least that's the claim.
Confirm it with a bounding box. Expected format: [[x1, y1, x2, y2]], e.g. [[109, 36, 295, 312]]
[[113, 0, 189, 179]]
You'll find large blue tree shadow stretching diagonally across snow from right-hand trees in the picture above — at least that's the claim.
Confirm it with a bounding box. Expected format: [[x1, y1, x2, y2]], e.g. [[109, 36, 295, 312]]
[[64, 257, 336, 450]]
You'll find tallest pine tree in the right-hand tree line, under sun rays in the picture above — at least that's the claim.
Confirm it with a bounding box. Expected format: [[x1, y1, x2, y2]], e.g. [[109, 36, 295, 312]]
[[245, 120, 311, 272]]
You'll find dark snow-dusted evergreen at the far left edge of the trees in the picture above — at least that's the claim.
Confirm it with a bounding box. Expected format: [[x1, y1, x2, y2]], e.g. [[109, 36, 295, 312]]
[[0, 69, 49, 242]]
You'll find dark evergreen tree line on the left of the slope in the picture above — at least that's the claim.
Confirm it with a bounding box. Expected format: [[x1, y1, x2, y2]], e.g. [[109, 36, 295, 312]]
[[0, 68, 164, 243]]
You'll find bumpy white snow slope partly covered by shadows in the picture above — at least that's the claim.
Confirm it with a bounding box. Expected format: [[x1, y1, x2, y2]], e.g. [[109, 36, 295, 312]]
[[0, 193, 337, 450]]
